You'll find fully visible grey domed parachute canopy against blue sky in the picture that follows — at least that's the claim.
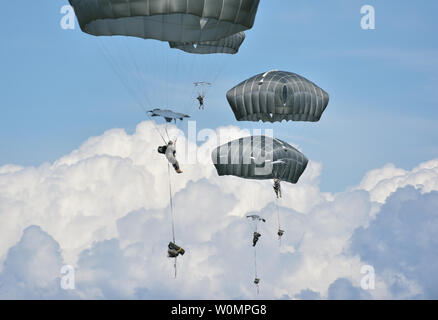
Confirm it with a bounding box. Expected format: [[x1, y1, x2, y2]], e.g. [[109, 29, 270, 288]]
[[227, 70, 329, 122]]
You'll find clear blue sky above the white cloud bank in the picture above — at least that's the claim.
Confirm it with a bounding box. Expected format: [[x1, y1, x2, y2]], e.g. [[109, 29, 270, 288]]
[[0, 0, 438, 191]]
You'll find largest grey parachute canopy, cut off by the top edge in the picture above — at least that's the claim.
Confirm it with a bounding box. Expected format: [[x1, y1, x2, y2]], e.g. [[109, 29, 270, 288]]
[[69, 0, 260, 42]]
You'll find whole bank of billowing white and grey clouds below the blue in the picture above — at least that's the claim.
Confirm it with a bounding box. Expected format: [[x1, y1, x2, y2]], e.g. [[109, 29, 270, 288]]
[[0, 121, 438, 299]]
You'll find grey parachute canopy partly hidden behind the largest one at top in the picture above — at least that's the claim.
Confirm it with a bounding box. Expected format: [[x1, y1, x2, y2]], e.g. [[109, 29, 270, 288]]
[[169, 32, 245, 54]]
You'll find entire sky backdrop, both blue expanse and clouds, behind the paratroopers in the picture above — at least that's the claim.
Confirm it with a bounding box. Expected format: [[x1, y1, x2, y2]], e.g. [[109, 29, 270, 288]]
[[0, 0, 438, 299]]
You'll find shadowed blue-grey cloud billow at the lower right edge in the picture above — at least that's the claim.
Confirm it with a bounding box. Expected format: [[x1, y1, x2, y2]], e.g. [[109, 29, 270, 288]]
[[351, 186, 438, 299]]
